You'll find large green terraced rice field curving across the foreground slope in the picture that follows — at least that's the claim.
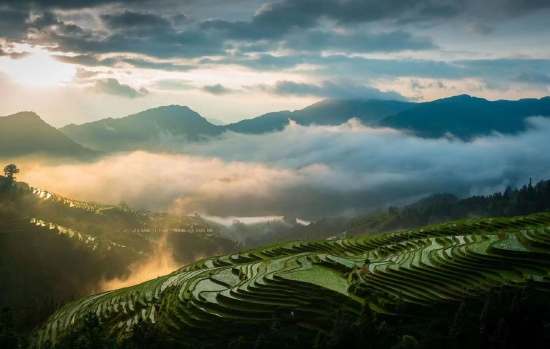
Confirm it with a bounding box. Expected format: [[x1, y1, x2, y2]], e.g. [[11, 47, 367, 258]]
[[31, 214, 550, 343]]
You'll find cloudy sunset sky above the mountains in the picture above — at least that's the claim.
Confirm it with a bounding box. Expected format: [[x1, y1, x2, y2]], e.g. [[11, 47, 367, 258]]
[[0, 0, 550, 127]]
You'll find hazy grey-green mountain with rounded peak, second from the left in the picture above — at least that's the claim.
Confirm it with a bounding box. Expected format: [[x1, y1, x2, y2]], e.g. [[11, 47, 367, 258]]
[[59, 105, 224, 152]]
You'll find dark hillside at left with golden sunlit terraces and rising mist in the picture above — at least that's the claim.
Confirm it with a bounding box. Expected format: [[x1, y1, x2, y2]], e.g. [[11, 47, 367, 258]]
[[0, 178, 239, 310]]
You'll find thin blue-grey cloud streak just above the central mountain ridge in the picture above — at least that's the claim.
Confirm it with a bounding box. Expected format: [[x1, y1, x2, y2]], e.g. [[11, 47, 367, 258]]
[[252, 81, 405, 100]]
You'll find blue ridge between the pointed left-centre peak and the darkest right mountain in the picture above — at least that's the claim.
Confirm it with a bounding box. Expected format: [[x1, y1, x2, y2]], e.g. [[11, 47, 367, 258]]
[[227, 99, 415, 134]]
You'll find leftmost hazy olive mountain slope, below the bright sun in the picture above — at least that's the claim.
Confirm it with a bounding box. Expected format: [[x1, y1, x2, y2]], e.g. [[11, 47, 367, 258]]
[[0, 112, 101, 160]]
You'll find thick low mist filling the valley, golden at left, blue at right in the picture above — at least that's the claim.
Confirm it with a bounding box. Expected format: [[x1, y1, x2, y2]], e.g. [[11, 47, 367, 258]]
[[19, 117, 550, 220]]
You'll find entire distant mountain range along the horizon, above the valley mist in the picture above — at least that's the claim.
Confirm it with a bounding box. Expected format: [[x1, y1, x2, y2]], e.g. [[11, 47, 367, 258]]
[[0, 95, 550, 159]]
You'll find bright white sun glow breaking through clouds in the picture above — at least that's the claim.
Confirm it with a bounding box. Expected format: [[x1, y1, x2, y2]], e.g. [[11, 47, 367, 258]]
[[0, 51, 76, 87]]
